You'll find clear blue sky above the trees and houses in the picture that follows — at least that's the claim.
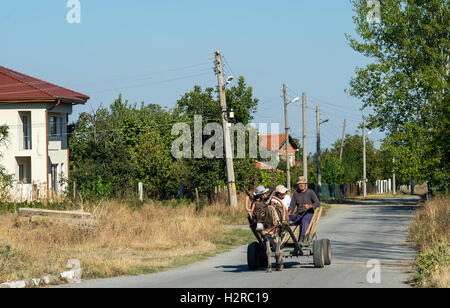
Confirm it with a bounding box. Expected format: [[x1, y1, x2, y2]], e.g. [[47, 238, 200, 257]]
[[0, 0, 383, 152]]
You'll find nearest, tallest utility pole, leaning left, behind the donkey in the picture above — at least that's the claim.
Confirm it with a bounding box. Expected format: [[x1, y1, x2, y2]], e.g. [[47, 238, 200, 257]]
[[215, 51, 237, 207]]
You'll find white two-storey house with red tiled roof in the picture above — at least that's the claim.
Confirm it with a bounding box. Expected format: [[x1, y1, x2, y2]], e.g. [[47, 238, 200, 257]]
[[0, 66, 89, 199]]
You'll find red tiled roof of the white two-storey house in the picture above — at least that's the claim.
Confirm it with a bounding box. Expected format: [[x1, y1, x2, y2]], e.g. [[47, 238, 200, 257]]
[[0, 66, 89, 104]]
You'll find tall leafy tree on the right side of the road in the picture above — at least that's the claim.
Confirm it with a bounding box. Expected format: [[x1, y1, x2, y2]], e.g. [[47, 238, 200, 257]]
[[347, 0, 450, 187]]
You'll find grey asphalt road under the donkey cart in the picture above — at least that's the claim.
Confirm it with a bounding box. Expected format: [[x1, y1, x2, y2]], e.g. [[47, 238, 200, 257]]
[[61, 197, 418, 288]]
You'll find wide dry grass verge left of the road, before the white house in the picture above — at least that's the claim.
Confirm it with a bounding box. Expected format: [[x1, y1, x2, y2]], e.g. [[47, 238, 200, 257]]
[[0, 202, 252, 282]]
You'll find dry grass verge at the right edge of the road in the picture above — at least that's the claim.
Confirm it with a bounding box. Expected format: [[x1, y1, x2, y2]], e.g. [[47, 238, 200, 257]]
[[410, 196, 450, 288]]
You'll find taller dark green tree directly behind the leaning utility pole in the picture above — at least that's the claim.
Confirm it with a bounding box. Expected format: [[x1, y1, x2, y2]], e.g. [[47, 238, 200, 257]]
[[176, 76, 260, 192]]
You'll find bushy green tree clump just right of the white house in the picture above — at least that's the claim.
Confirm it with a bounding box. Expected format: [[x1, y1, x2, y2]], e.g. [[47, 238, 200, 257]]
[[69, 96, 184, 198]]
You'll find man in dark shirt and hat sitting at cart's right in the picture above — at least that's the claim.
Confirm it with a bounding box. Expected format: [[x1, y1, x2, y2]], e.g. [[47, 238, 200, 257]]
[[289, 176, 320, 240]]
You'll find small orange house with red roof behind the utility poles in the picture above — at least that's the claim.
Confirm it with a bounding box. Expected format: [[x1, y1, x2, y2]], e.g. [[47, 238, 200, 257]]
[[256, 134, 299, 169]]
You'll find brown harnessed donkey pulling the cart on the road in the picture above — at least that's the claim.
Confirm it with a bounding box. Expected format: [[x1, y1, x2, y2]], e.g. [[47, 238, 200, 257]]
[[247, 192, 286, 273]]
